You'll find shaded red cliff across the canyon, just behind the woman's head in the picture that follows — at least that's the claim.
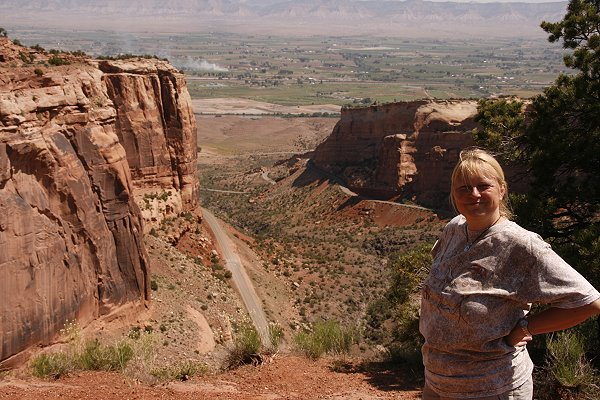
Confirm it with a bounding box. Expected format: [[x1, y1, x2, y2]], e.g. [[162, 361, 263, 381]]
[[313, 100, 477, 208]]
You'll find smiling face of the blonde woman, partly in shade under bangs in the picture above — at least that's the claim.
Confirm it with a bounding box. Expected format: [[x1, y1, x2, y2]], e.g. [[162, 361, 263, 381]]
[[452, 174, 506, 228]]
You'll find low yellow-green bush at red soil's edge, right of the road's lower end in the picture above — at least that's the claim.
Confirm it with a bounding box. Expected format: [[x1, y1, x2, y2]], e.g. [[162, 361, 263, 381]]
[[294, 320, 358, 359]]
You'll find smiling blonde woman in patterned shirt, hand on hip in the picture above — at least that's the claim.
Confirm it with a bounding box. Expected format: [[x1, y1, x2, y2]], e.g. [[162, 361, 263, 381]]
[[420, 149, 600, 400]]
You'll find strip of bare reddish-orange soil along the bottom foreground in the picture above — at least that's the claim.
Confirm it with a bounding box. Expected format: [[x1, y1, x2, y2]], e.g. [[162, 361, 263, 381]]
[[0, 356, 420, 400]]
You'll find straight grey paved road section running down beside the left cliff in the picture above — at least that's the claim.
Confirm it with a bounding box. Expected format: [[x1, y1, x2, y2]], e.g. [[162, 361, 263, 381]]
[[202, 208, 272, 348]]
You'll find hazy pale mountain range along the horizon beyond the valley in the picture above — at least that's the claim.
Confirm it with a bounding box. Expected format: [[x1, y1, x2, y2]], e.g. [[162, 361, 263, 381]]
[[0, 0, 567, 37]]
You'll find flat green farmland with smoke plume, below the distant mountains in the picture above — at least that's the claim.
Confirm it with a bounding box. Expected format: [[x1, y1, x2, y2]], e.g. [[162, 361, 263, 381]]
[[9, 29, 568, 105]]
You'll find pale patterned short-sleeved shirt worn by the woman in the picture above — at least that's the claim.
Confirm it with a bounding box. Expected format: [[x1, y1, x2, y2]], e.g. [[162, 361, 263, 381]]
[[419, 215, 600, 398]]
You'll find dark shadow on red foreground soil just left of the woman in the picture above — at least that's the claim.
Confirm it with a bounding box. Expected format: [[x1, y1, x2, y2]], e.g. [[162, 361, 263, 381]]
[[335, 361, 425, 392]]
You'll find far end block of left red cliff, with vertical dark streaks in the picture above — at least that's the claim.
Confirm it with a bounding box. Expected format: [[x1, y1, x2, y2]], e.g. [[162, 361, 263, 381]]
[[99, 59, 198, 231]]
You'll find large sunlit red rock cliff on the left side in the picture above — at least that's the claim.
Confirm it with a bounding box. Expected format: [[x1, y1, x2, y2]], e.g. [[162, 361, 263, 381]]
[[0, 37, 197, 361]]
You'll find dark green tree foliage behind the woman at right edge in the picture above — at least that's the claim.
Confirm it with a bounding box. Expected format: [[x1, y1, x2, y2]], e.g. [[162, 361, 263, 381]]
[[475, 0, 600, 286]]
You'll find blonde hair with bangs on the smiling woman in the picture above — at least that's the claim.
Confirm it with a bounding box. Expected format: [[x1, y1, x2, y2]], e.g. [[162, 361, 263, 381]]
[[450, 147, 513, 218]]
